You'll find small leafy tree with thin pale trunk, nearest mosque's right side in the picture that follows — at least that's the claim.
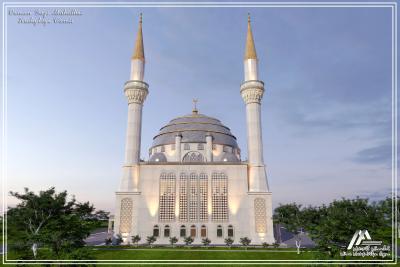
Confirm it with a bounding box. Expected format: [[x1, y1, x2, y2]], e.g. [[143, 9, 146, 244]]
[[274, 203, 304, 254]]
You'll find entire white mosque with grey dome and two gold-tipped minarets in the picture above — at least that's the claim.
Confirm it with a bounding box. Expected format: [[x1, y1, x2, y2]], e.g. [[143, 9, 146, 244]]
[[113, 14, 275, 245]]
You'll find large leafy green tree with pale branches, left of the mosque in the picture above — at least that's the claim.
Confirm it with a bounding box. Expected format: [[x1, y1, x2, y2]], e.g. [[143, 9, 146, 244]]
[[6, 187, 98, 258]]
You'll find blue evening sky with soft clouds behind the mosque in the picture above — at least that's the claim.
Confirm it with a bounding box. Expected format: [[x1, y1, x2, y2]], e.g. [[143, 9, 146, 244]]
[[3, 3, 392, 214]]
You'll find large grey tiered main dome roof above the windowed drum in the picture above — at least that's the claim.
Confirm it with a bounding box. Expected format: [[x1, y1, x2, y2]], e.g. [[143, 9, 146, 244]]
[[153, 113, 238, 148]]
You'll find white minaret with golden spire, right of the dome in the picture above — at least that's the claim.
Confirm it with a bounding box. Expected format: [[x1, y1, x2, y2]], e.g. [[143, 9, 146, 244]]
[[240, 15, 269, 192]]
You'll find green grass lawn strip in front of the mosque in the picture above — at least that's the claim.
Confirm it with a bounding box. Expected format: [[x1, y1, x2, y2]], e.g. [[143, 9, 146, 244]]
[[5, 246, 394, 266]]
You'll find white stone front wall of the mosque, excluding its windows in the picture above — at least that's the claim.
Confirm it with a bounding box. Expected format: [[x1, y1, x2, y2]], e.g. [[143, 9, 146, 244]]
[[115, 163, 273, 244]]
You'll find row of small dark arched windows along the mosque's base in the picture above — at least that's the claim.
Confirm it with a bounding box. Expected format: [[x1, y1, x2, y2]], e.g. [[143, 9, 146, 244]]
[[153, 225, 234, 238]]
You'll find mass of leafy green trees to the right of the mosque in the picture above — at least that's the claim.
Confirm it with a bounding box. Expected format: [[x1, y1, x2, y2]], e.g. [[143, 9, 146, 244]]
[[274, 197, 398, 257]]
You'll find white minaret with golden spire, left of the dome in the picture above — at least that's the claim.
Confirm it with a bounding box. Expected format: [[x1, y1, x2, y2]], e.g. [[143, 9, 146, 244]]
[[120, 14, 149, 192]]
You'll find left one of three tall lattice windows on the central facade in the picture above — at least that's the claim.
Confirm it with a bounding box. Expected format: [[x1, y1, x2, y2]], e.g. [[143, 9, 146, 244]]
[[159, 172, 175, 222]]
